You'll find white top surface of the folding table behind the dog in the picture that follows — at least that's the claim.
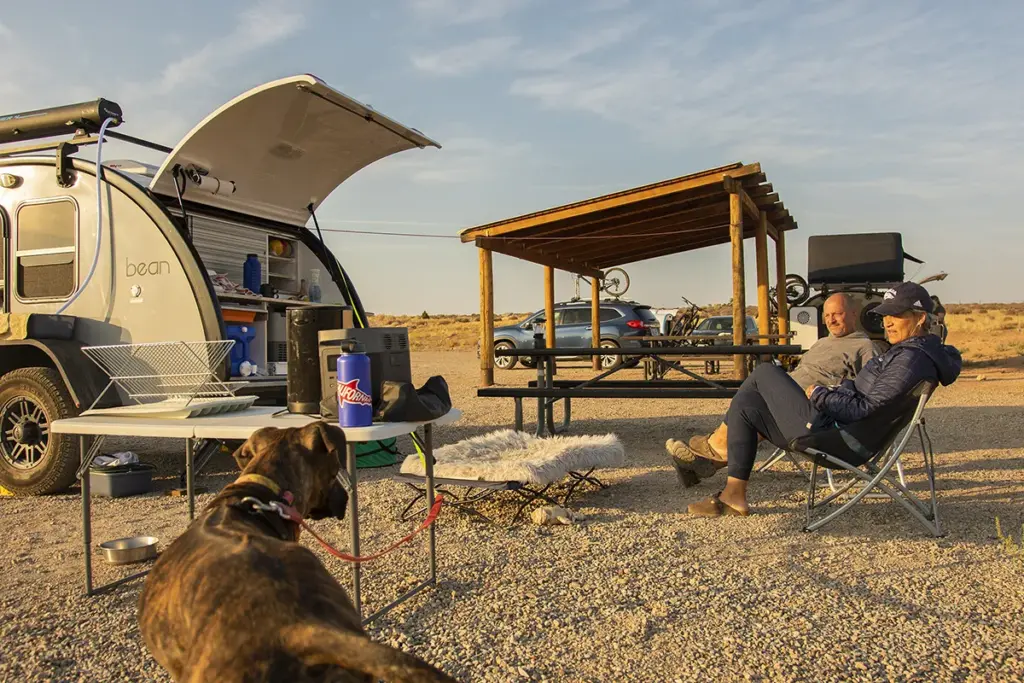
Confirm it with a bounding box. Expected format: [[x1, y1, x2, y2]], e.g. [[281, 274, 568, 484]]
[[50, 405, 462, 443]]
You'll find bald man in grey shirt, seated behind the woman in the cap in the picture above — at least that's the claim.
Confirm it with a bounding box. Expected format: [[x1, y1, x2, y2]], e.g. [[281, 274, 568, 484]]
[[665, 293, 883, 486]]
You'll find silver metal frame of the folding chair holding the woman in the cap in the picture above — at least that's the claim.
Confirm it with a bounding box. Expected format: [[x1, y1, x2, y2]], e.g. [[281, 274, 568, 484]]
[[790, 383, 945, 537]]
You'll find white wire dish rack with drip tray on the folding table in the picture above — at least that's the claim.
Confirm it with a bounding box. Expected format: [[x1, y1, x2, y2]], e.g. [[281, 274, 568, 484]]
[[82, 339, 256, 418]]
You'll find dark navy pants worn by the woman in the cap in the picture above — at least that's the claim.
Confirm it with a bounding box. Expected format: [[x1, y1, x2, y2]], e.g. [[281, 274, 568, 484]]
[[725, 364, 818, 481]]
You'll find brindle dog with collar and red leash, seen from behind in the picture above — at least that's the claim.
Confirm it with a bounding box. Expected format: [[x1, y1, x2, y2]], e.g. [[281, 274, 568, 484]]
[[138, 422, 454, 683]]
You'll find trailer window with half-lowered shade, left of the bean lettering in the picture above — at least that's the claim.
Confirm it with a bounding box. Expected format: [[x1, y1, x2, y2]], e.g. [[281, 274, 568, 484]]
[[14, 200, 78, 300]]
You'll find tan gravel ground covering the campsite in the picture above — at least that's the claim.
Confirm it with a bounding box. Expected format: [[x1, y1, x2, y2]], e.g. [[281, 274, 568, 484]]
[[0, 352, 1024, 681]]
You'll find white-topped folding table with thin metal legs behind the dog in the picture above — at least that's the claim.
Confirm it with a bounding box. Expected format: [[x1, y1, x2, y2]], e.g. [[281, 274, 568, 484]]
[[50, 407, 462, 624]]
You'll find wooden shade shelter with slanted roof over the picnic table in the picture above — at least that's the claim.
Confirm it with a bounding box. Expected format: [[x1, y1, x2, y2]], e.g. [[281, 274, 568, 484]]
[[460, 163, 797, 386]]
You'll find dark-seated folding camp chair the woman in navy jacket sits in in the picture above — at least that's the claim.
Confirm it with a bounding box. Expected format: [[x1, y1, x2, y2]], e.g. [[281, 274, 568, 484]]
[[785, 381, 944, 537]]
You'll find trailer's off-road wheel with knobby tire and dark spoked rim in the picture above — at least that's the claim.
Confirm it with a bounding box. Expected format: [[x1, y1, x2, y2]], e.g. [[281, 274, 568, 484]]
[[0, 368, 79, 496]]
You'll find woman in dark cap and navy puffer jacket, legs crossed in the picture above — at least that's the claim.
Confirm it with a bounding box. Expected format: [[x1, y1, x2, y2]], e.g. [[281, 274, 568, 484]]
[[673, 283, 962, 517]]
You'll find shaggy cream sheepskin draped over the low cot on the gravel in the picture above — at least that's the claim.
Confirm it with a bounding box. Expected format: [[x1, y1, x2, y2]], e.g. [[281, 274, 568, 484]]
[[401, 429, 626, 486]]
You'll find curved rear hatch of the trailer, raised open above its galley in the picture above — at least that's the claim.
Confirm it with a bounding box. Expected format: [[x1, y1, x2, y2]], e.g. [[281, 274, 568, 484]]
[[150, 75, 440, 225]]
